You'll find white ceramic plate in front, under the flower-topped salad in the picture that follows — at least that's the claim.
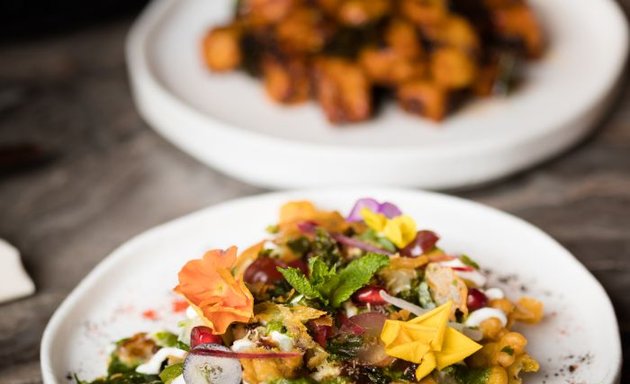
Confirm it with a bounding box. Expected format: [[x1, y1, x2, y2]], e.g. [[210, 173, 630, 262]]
[[41, 188, 621, 384]]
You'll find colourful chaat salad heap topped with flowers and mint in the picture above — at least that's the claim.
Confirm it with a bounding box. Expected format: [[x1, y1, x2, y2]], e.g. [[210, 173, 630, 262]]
[[81, 198, 543, 384]]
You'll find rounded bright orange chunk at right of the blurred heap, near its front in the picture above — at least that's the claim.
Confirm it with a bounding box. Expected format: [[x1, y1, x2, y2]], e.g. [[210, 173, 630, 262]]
[[430, 48, 477, 89]]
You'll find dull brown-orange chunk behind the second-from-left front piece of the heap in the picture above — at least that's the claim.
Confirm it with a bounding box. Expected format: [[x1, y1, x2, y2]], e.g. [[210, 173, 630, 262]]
[[276, 7, 331, 53]]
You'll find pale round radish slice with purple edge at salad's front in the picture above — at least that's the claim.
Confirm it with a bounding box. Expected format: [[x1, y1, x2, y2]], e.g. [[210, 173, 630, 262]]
[[184, 344, 243, 384]]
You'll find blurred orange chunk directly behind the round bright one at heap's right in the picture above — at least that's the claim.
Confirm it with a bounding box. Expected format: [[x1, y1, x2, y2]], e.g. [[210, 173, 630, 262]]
[[422, 16, 479, 54]]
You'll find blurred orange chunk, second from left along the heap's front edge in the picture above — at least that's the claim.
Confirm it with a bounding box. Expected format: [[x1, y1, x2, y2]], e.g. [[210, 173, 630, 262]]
[[262, 55, 311, 104]]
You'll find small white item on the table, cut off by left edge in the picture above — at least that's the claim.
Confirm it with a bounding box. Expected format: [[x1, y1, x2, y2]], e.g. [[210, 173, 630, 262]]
[[0, 239, 35, 303]]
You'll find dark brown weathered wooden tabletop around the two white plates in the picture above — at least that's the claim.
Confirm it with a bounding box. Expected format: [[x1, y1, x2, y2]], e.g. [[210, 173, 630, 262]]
[[0, 8, 630, 384]]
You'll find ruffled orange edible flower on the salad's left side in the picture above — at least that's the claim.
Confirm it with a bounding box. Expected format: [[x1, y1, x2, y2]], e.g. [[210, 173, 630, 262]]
[[174, 247, 254, 335]]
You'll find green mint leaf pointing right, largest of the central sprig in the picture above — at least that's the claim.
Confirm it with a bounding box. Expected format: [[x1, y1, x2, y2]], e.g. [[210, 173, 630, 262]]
[[330, 253, 389, 307]]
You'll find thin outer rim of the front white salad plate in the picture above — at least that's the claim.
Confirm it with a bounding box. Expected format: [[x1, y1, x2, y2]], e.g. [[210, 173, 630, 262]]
[[40, 186, 623, 384]]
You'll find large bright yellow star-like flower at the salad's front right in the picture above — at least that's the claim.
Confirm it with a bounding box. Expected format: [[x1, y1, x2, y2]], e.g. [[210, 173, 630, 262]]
[[381, 301, 481, 380]]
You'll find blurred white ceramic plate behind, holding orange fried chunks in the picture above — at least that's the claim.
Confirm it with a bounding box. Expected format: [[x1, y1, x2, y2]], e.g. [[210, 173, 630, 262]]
[[127, 0, 628, 188]]
